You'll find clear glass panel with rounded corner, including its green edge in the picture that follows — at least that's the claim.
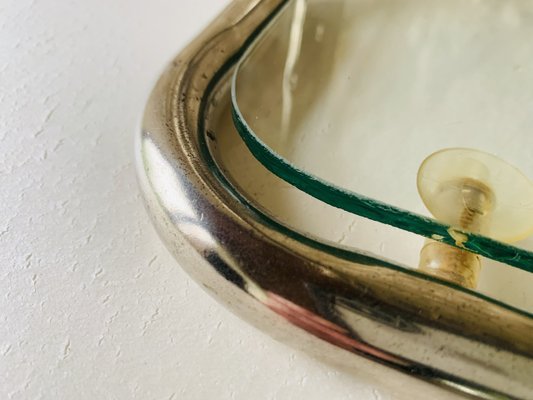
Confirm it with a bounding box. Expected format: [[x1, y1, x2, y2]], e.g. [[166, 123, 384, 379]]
[[232, 0, 533, 272]]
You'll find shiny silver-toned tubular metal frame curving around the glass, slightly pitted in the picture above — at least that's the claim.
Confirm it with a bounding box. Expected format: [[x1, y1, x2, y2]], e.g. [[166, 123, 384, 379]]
[[137, 0, 533, 398]]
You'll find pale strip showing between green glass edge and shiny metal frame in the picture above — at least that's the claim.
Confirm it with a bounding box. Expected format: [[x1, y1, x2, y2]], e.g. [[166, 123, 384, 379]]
[[207, 80, 533, 316]]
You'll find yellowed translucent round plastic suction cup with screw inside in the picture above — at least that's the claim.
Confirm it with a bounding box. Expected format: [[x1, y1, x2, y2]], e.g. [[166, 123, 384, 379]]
[[417, 148, 533, 243]]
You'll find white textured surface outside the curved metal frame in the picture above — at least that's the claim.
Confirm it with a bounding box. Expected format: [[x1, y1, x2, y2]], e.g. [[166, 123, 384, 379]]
[[0, 0, 385, 399]]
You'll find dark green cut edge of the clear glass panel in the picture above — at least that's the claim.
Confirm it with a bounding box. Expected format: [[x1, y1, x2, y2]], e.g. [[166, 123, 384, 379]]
[[231, 45, 533, 273]]
